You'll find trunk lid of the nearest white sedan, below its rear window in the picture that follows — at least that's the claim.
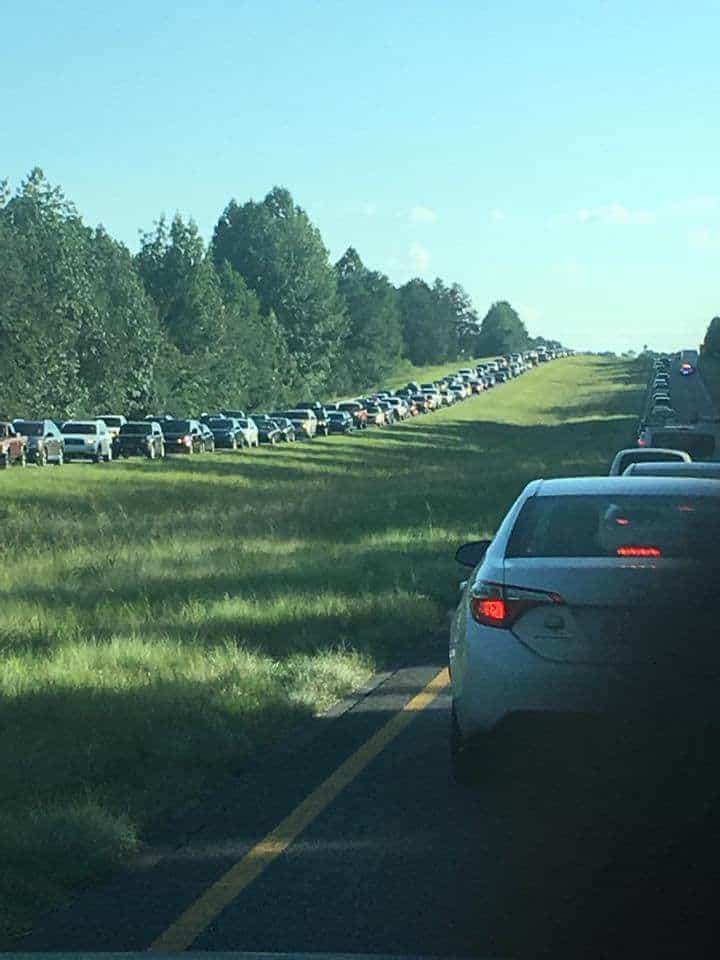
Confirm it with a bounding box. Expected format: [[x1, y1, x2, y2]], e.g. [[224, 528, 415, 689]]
[[505, 557, 720, 675]]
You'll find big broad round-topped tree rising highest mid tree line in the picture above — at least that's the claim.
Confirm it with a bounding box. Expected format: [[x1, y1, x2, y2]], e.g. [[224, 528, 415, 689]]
[[212, 187, 347, 396]]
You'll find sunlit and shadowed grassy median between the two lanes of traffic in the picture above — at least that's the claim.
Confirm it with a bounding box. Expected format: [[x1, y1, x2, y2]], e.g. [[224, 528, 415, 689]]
[[0, 357, 644, 937]]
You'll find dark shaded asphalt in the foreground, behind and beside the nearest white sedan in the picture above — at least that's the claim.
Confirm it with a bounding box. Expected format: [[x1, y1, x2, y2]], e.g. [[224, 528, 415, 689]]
[[9, 642, 720, 957]]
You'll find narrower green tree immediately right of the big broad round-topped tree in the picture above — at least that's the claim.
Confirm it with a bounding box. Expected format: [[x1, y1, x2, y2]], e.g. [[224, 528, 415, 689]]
[[335, 247, 403, 389]]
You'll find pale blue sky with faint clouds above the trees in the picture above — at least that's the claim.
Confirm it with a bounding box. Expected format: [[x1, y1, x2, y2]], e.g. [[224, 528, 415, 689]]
[[0, 0, 720, 350]]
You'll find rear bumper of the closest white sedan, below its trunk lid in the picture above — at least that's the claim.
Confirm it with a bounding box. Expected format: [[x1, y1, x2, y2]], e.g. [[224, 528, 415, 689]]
[[451, 627, 720, 736]]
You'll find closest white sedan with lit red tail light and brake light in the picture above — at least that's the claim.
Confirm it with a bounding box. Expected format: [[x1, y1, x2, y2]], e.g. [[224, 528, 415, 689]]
[[449, 477, 720, 783]]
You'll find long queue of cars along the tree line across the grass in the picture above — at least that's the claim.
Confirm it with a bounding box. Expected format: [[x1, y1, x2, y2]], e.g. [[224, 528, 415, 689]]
[[0, 348, 570, 468]]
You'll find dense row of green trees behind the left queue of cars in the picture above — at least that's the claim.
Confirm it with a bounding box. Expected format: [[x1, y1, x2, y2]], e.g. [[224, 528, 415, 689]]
[[0, 169, 560, 417]]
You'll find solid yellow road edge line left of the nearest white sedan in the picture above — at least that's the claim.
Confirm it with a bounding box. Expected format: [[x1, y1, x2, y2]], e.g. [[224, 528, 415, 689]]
[[150, 669, 450, 953]]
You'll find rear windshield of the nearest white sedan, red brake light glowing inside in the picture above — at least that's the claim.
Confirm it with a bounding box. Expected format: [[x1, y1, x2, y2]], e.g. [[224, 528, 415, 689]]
[[506, 494, 720, 559]]
